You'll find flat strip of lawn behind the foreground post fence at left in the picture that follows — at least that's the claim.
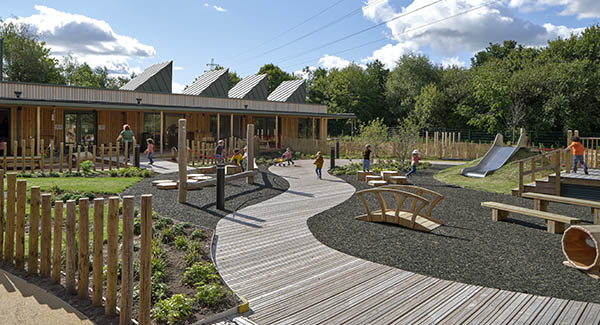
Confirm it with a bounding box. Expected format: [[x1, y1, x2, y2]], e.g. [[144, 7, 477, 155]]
[[4, 177, 142, 194]]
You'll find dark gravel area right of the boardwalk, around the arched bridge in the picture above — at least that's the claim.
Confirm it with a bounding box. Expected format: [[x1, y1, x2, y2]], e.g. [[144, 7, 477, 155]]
[[307, 166, 600, 303]]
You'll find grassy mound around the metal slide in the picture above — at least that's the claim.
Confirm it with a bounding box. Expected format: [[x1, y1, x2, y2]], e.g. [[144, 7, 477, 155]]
[[434, 149, 552, 194]]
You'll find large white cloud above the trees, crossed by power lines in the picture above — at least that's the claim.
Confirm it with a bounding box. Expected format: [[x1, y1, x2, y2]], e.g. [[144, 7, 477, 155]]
[[363, 0, 581, 68]]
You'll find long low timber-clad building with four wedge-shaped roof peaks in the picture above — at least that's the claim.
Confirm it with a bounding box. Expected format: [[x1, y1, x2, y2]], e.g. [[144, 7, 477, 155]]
[[0, 61, 354, 153]]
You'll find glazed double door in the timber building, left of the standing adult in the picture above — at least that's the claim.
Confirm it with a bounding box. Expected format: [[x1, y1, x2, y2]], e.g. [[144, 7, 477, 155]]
[[65, 112, 97, 146]]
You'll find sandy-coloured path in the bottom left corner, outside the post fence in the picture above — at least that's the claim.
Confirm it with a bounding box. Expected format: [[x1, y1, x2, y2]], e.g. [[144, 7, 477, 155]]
[[0, 270, 93, 325]]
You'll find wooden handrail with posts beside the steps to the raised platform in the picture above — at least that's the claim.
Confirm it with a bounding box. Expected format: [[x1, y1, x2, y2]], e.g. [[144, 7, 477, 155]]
[[518, 149, 571, 196]]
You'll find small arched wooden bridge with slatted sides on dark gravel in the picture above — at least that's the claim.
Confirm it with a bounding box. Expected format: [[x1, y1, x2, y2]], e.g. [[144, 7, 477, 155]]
[[356, 185, 444, 232]]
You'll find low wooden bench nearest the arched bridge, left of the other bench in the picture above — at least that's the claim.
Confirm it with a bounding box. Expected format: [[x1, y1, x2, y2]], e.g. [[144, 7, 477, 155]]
[[481, 202, 581, 234]]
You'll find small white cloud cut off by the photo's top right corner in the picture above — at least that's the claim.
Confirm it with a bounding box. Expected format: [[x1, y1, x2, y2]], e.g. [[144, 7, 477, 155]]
[[508, 0, 600, 19]]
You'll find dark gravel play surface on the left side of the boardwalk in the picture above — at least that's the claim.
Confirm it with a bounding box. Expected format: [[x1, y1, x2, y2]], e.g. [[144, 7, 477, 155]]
[[122, 167, 291, 230]]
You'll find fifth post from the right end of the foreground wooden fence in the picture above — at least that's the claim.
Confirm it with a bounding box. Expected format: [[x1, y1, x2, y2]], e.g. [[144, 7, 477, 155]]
[[77, 198, 90, 299]]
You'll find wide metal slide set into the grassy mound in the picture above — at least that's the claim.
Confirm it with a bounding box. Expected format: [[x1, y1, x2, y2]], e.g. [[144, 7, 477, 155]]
[[461, 129, 527, 178]]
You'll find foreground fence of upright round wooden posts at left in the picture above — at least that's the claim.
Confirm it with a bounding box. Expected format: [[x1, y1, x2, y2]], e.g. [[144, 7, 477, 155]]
[[0, 170, 152, 324]]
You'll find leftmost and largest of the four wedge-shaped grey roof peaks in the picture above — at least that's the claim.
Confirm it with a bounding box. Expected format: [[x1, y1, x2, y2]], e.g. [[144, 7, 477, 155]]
[[121, 61, 173, 93]]
